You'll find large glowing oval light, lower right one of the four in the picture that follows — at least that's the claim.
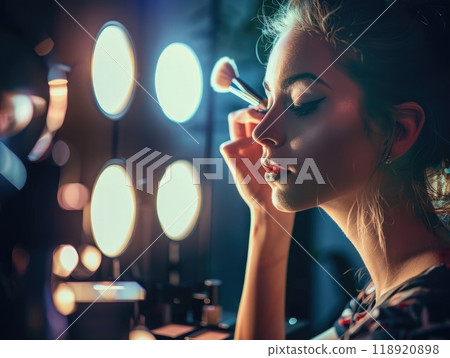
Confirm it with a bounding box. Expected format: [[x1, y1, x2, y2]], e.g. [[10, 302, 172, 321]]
[[156, 160, 201, 240]]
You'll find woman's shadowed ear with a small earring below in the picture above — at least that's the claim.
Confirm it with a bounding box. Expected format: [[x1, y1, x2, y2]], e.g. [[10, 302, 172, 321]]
[[390, 102, 425, 160]]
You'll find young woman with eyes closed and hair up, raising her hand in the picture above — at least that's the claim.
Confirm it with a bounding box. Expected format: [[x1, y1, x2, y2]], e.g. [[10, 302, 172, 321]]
[[221, 0, 450, 339]]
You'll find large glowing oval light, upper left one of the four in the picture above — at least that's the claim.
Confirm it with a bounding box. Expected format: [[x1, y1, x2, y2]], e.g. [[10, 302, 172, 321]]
[[91, 21, 136, 119]]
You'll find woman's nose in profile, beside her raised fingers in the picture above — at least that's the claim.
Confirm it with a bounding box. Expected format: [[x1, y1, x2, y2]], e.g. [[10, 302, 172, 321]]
[[252, 106, 285, 147]]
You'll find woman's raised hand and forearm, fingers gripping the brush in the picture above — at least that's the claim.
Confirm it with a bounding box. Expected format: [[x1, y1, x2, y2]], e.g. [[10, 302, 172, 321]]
[[220, 104, 294, 339]]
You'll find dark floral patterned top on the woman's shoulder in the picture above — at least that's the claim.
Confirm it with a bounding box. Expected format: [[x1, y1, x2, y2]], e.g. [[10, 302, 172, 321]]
[[334, 264, 450, 339]]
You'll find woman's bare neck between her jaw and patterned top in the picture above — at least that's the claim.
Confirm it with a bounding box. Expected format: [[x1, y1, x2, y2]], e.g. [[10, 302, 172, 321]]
[[321, 194, 444, 299]]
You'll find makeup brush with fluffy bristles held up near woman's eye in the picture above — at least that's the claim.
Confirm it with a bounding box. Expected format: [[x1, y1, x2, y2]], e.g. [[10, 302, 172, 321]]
[[211, 56, 263, 106]]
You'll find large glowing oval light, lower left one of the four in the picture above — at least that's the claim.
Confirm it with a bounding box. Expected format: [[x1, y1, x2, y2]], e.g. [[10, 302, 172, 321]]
[[91, 163, 136, 257]]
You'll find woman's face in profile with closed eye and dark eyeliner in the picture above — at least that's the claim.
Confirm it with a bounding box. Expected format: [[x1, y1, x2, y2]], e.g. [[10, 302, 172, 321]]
[[253, 30, 388, 211]]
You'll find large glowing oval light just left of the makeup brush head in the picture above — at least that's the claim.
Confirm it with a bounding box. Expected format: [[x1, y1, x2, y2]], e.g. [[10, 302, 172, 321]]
[[155, 43, 203, 123]]
